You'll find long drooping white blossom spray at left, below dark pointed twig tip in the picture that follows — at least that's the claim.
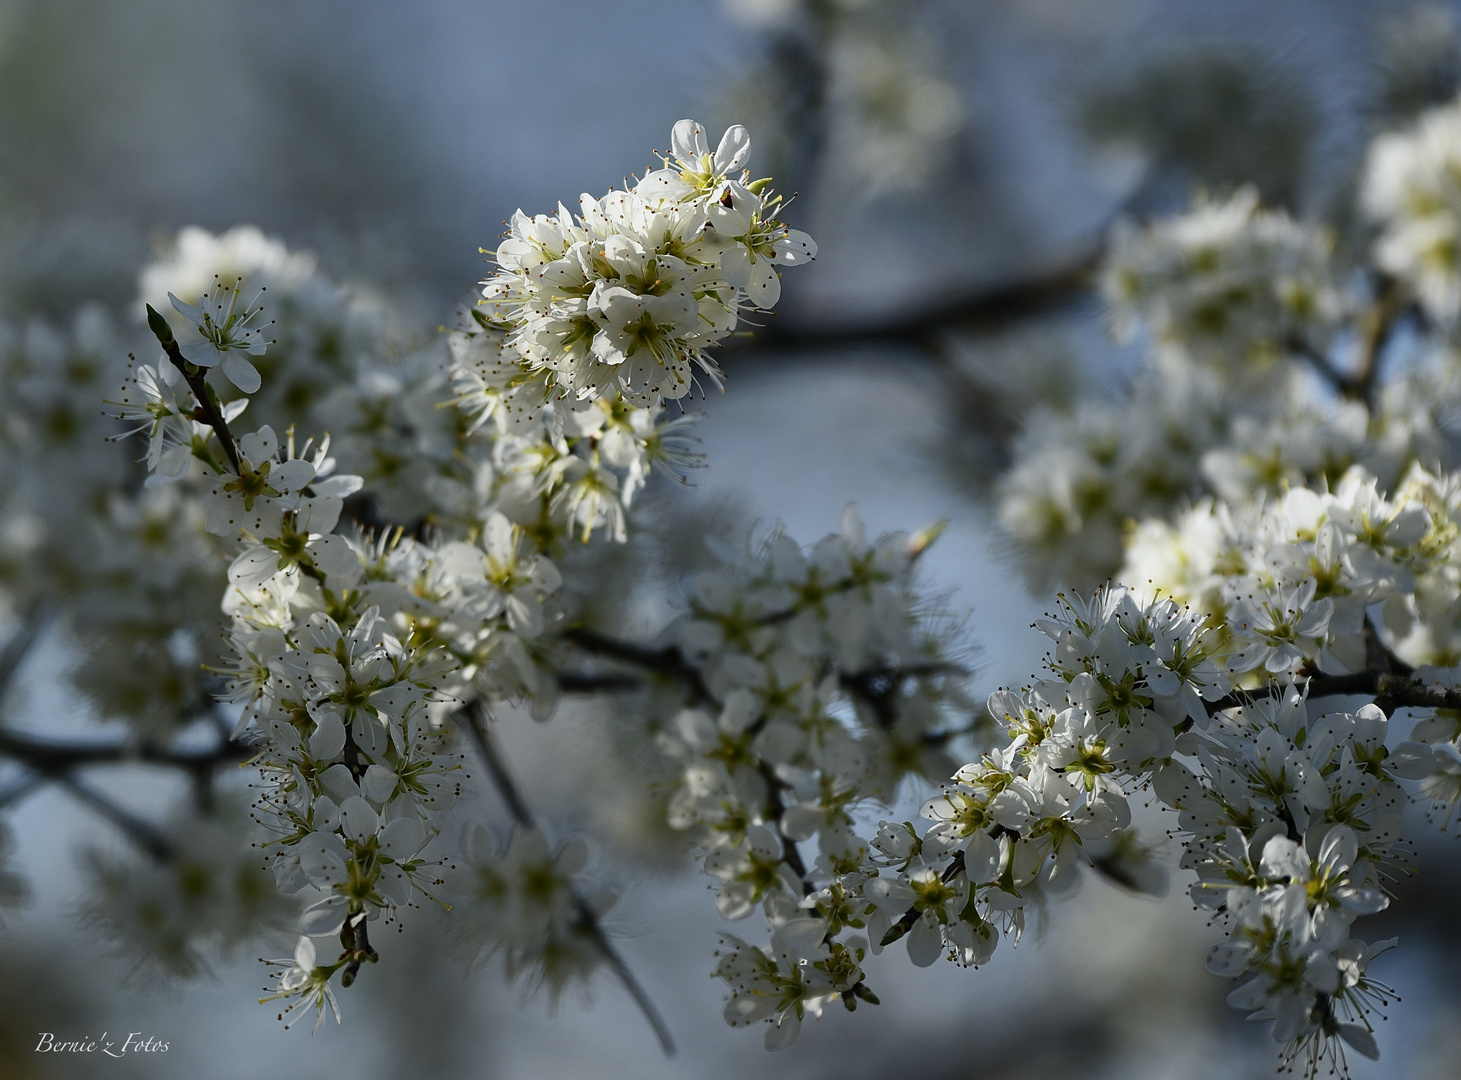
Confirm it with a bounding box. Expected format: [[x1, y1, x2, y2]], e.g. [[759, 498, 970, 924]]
[[115, 265, 639, 1022]]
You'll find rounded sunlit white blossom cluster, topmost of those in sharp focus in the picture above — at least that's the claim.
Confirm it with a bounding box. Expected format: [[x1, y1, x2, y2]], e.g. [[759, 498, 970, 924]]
[[482, 120, 817, 414]]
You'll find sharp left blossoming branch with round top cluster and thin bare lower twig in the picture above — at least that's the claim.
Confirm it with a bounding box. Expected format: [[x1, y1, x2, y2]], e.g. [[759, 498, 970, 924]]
[[85, 121, 835, 1048]]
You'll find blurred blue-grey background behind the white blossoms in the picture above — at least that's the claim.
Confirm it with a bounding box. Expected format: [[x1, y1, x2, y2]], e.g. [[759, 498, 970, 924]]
[[0, 0, 1461, 1080]]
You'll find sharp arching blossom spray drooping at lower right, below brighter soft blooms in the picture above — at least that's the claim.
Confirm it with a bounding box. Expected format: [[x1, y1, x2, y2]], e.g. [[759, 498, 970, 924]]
[[975, 587, 1433, 1076]]
